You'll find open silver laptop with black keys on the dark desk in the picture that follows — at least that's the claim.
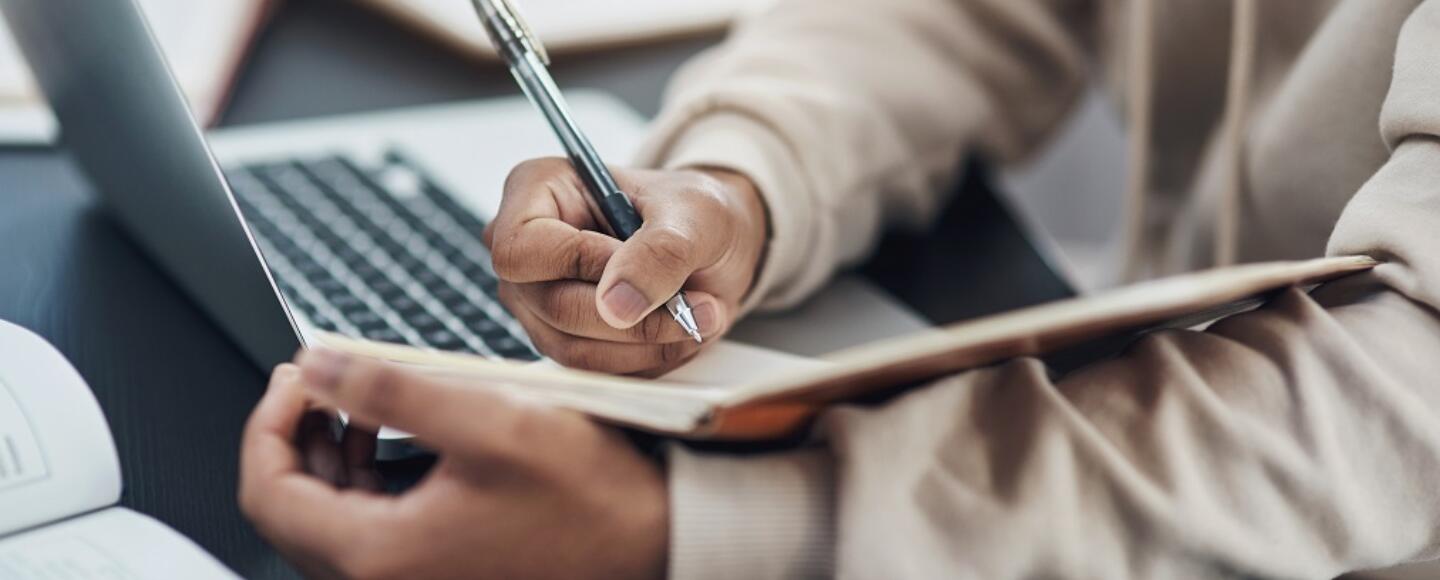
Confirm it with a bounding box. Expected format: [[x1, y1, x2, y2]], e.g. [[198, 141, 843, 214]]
[[0, 0, 659, 368]]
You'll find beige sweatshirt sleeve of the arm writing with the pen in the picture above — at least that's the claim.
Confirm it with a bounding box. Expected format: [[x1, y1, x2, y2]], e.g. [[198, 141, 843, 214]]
[[638, 0, 1093, 307]]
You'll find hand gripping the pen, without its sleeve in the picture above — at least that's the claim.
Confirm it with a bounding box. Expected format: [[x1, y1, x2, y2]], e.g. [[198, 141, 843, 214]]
[[485, 158, 768, 374]]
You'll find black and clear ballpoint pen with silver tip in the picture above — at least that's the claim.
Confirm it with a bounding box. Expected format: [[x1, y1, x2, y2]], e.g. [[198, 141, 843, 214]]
[[471, 0, 703, 343]]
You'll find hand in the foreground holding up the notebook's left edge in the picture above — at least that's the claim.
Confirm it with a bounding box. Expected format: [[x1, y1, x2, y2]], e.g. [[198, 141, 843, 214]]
[[239, 353, 668, 579]]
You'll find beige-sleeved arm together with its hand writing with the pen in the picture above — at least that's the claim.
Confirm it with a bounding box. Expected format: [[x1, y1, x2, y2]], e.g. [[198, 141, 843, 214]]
[[485, 0, 1093, 374]]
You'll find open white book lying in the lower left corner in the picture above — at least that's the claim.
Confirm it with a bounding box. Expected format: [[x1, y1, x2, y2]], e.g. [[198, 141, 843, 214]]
[[0, 322, 238, 579]]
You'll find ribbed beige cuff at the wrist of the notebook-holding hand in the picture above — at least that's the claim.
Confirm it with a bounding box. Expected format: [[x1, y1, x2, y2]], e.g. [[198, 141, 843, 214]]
[[670, 446, 835, 580]]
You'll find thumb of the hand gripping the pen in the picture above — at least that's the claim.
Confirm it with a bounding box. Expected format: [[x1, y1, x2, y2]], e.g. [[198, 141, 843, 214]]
[[596, 196, 730, 328]]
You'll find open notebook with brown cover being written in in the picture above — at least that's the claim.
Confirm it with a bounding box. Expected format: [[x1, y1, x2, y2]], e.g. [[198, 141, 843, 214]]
[[318, 256, 1377, 442]]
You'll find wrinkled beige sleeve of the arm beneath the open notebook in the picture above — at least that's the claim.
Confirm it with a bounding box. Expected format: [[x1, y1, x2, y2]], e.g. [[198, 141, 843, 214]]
[[672, 0, 1440, 579]]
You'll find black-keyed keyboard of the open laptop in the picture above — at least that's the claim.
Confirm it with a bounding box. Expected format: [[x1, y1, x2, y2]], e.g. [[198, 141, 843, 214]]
[[226, 151, 540, 361]]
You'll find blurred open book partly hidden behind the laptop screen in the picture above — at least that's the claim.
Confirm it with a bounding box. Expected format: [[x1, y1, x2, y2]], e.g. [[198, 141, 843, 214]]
[[0, 0, 268, 142]]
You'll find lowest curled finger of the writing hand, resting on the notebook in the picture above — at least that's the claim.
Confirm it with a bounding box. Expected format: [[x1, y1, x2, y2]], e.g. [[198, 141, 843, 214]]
[[514, 290, 700, 376]]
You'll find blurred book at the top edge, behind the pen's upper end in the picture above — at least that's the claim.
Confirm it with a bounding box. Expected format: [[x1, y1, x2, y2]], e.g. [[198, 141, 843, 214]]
[[363, 0, 773, 58]]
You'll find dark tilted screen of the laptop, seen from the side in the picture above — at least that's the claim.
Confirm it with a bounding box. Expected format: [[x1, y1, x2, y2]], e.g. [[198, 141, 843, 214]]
[[0, 0, 301, 368]]
